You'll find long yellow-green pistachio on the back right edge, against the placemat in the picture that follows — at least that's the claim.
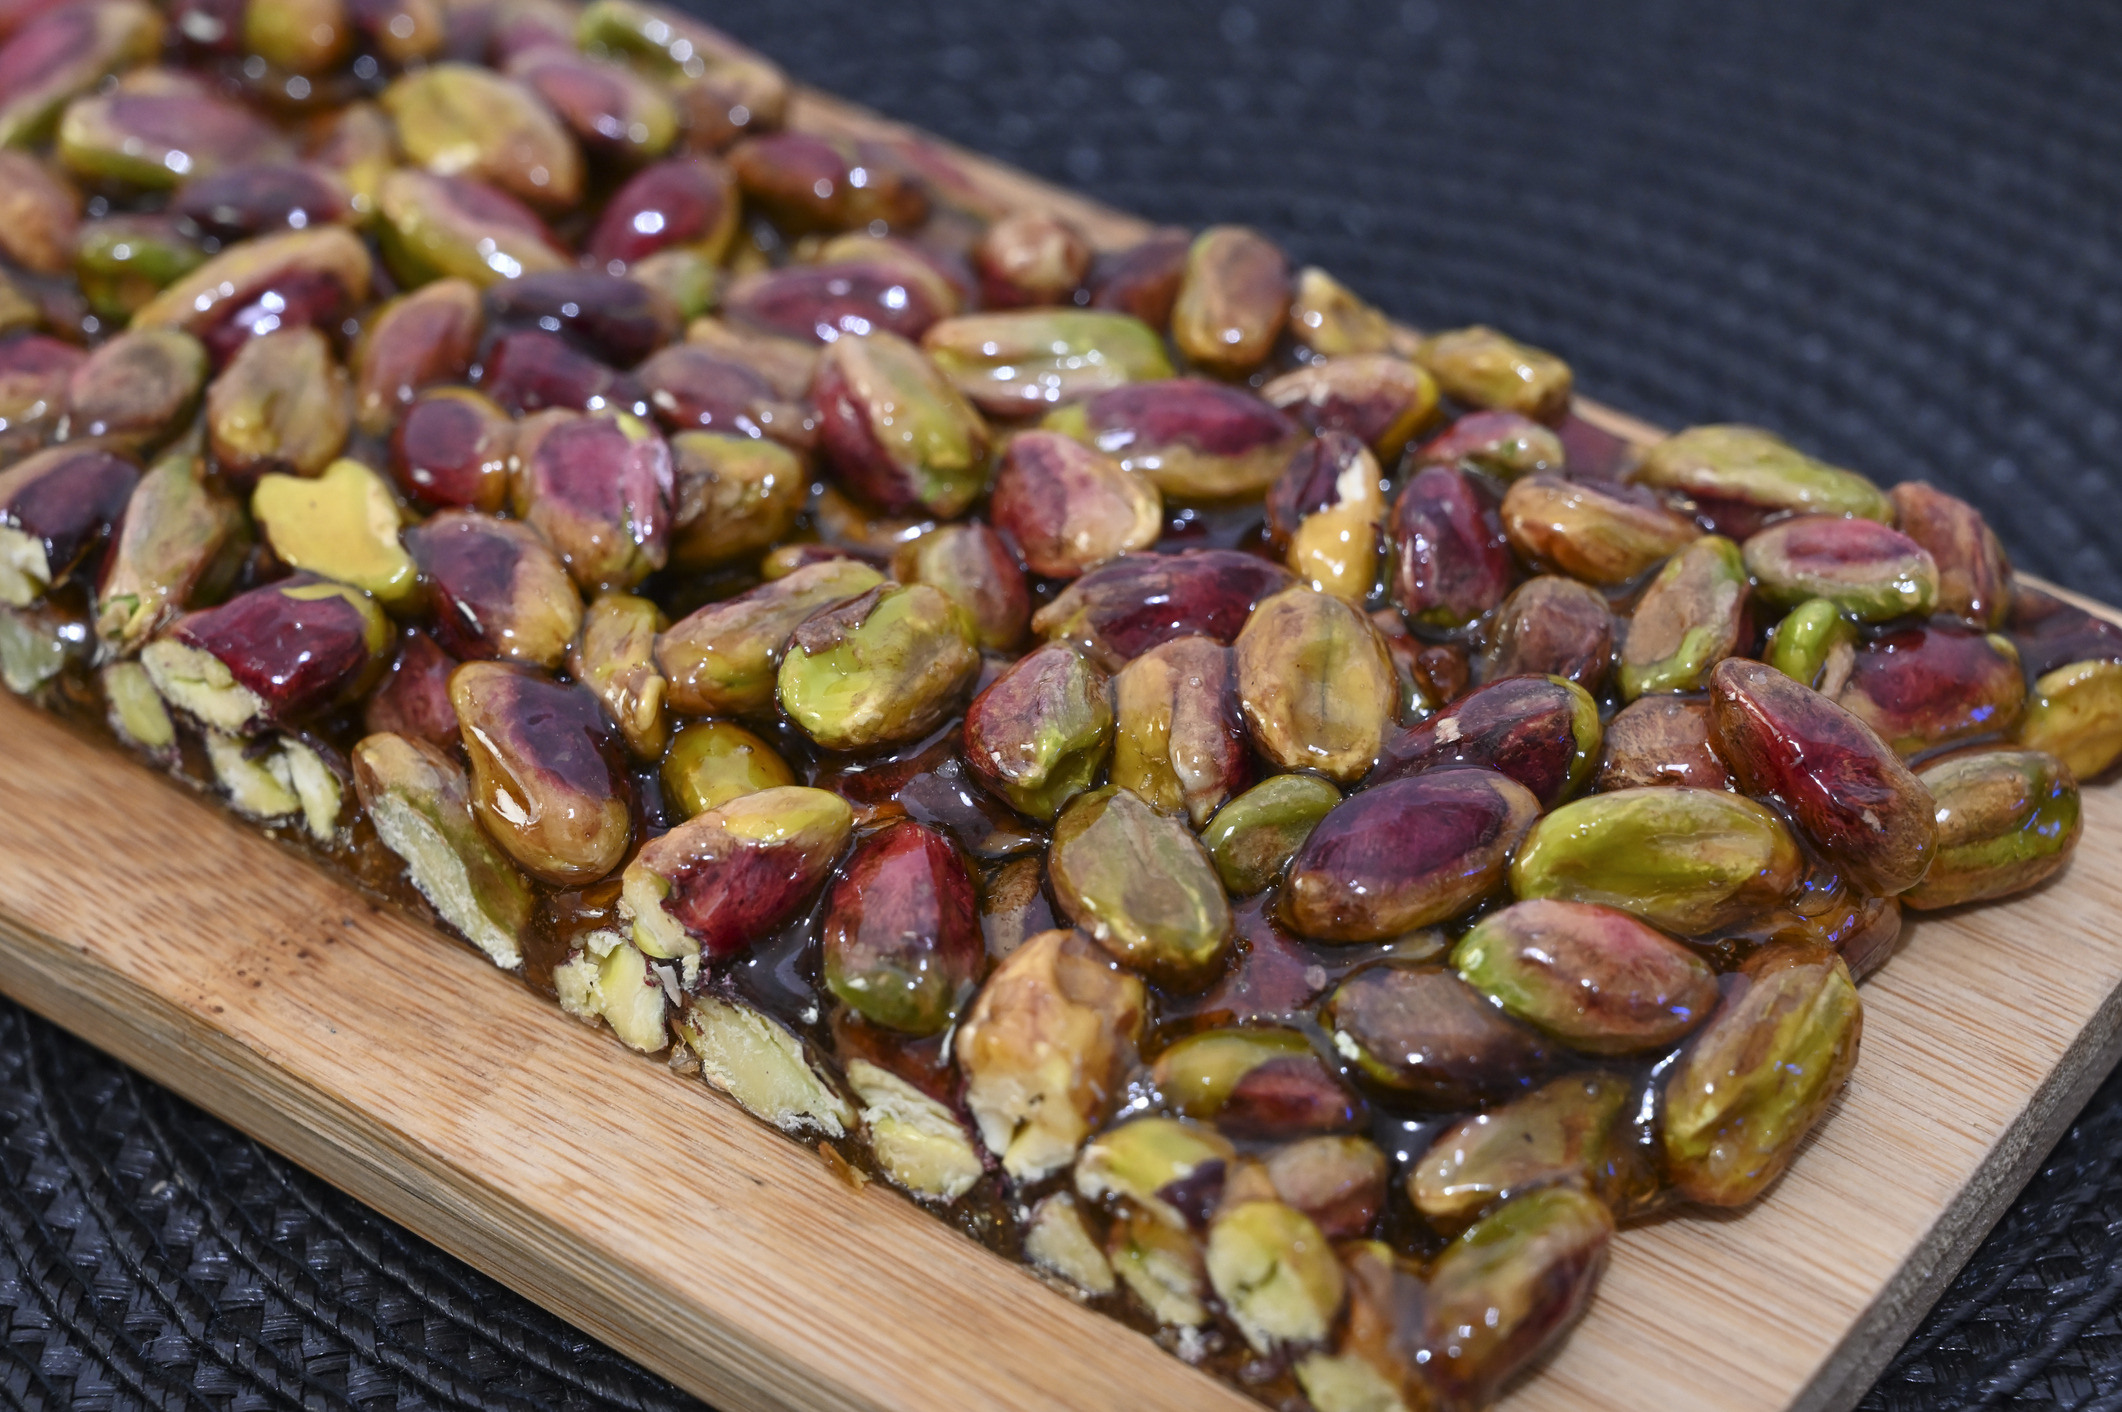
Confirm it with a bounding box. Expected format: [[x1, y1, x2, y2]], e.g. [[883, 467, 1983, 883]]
[[1630, 425, 1895, 524]]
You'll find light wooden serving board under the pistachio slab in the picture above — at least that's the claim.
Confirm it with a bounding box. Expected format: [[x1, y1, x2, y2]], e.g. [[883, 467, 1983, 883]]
[[0, 82, 2122, 1412]]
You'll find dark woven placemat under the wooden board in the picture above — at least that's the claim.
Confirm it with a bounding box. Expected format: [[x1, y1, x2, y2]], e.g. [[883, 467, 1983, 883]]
[[0, 0, 2122, 1412]]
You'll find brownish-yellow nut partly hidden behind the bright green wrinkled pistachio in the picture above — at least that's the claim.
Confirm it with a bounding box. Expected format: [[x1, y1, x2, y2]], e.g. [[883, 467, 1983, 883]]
[[656, 558, 883, 716]]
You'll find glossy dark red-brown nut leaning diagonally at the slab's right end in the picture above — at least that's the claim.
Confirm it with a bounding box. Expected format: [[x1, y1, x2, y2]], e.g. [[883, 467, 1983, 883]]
[[1710, 658, 1937, 896]]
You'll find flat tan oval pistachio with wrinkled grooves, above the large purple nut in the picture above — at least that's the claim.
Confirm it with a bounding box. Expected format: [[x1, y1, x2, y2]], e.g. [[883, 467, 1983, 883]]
[[1233, 586, 1398, 784]]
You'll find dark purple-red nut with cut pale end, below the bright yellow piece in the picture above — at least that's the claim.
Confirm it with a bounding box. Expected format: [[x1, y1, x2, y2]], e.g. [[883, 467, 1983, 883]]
[[140, 573, 393, 735]]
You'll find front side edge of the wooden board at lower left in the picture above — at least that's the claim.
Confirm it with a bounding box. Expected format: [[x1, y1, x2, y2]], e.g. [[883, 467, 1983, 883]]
[[0, 913, 870, 1412]]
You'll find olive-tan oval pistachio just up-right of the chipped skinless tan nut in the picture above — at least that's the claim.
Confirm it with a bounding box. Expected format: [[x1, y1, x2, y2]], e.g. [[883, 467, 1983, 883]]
[[1046, 788, 1231, 992]]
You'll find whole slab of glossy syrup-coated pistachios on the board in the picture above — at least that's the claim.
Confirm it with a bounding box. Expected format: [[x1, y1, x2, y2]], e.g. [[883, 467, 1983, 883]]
[[0, 0, 2122, 1412]]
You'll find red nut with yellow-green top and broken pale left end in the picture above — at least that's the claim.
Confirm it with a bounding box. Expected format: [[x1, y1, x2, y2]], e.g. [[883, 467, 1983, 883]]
[[622, 786, 855, 962]]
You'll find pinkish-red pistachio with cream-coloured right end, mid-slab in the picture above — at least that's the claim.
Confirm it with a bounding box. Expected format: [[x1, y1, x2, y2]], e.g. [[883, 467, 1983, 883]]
[[989, 431, 1165, 578]]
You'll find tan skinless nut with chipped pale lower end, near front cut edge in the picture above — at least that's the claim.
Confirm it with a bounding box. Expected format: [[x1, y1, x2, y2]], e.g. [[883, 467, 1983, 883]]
[[953, 930, 1146, 1183]]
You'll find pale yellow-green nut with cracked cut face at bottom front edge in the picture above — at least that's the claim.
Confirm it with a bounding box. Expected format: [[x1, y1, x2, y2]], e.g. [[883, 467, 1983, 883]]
[[1207, 1202, 1345, 1355]]
